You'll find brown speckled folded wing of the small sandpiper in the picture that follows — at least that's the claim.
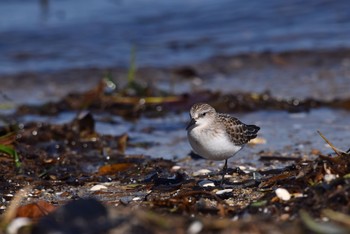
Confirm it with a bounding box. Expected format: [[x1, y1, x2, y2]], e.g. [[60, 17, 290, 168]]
[[218, 113, 260, 145]]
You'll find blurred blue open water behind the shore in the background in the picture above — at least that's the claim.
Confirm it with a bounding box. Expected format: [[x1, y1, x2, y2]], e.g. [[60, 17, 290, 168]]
[[0, 0, 350, 74]]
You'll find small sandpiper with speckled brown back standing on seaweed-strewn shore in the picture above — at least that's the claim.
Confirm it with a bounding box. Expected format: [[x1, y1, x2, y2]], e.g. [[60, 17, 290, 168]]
[[186, 103, 260, 186]]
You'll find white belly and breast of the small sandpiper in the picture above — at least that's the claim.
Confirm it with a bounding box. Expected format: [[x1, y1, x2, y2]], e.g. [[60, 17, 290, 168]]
[[187, 128, 242, 160]]
